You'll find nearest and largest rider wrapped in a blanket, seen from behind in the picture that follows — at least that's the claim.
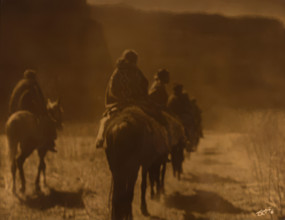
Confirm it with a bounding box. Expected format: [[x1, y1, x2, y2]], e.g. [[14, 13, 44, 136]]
[[96, 50, 184, 148]]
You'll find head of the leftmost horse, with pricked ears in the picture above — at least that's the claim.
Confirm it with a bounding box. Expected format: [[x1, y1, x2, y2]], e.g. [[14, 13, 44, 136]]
[[47, 99, 63, 130]]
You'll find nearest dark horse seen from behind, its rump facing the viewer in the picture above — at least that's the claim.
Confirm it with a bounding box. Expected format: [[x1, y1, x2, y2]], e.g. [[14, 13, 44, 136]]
[[105, 106, 184, 220]]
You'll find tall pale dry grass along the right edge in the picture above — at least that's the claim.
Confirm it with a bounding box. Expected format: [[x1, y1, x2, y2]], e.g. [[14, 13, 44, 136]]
[[241, 111, 285, 217]]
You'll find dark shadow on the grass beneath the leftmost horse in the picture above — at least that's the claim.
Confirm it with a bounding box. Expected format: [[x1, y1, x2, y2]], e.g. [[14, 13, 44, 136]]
[[16, 188, 85, 210]]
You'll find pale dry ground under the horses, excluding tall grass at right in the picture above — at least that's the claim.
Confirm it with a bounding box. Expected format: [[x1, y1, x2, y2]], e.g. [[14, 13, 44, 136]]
[[0, 119, 280, 220]]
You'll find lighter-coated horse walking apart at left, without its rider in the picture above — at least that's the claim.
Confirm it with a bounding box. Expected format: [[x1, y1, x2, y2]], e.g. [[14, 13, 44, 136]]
[[6, 100, 63, 193]]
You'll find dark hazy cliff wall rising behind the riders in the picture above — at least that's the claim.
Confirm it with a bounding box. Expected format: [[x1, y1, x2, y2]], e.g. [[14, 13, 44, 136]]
[[0, 0, 285, 129]]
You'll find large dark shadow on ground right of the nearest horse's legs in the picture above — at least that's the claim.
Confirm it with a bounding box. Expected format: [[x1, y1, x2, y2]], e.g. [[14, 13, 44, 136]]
[[165, 190, 245, 220]]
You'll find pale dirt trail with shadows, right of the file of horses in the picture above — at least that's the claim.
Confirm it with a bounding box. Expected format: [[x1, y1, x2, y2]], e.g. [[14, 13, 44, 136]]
[[131, 132, 264, 220]]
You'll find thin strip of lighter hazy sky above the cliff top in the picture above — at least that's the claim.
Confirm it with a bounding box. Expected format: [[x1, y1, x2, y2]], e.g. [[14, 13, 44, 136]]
[[88, 0, 285, 24]]
